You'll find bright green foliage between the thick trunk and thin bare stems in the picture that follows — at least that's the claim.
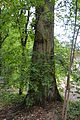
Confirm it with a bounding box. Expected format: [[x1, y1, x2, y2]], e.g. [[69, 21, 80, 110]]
[[55, 40, 70, 79]]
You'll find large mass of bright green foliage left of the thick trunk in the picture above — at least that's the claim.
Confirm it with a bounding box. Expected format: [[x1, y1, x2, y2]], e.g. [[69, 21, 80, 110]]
[[0, 0, 34, 91]]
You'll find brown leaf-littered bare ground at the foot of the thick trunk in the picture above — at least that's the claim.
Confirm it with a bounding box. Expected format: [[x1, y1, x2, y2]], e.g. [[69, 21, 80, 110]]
[[0, 102, 62, 120]]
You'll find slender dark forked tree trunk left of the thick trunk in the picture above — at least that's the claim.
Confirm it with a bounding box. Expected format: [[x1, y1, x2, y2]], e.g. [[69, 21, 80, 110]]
[[17, 9, 30, 95]]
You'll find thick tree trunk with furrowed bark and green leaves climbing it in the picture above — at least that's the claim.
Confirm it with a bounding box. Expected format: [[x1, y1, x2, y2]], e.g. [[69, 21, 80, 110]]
[[29, 0, 61, 103]]
